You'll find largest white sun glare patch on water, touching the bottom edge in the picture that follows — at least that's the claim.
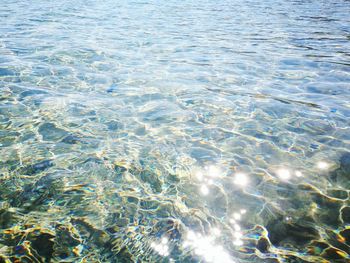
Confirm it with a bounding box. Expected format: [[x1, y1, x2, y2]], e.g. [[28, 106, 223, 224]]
[[183, 231, 234, 263]]
